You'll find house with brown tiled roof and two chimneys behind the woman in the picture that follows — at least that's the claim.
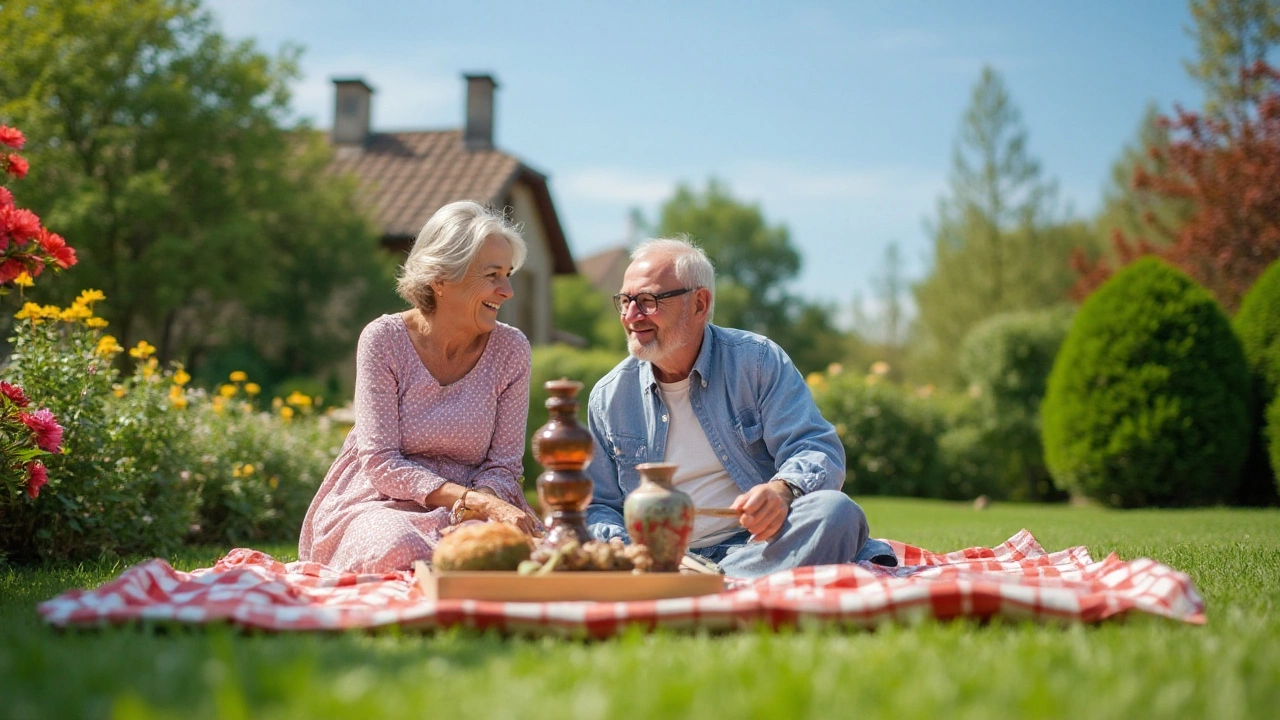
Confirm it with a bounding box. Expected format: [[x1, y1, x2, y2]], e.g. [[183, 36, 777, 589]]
[[332, 74, 576, 345]]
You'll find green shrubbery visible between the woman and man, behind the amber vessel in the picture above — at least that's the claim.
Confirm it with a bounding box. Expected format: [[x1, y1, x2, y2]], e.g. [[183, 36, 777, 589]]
[[525, 345, 626, 489]]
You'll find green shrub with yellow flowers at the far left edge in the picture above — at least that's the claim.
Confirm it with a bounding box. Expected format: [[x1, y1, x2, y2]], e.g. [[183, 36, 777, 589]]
[[0, 293, 196, 561]]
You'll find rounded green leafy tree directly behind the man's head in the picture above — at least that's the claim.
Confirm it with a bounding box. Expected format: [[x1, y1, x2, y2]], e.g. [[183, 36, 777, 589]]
[[654, 178, 847, 372]]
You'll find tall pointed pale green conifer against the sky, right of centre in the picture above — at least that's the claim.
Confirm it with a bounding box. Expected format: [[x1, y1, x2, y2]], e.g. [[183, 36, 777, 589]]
[[913, 68, 1089, 384]]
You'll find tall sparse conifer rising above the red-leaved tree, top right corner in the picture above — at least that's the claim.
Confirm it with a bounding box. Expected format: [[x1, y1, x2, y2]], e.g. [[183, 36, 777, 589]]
[[1185, 0, 1280, 118]]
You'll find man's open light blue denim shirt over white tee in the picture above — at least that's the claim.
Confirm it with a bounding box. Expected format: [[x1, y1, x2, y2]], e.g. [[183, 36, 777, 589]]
[[586, 324, 845, 539]]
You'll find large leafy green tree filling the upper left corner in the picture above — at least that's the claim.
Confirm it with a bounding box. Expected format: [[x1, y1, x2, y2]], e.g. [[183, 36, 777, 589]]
[[0, 0, 390, 386]]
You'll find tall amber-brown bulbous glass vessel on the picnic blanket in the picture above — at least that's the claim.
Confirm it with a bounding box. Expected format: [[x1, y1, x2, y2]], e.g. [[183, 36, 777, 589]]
[[532, 378, 595, 547]]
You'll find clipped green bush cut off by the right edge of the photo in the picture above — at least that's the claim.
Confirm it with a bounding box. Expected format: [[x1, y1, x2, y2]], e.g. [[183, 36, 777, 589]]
[[1233, 257, 1280, 503]]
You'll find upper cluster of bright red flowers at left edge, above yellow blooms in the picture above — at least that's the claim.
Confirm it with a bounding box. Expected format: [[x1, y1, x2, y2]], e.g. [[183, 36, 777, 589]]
[[0, 126, 76, 295]]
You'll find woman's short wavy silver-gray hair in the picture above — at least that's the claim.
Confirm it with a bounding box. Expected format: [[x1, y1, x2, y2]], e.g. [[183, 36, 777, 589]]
[[396, 200, 529, 314]]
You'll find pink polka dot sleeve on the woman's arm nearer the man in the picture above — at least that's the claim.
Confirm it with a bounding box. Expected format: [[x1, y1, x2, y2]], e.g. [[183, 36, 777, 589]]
[[471, 331, 532, 509]]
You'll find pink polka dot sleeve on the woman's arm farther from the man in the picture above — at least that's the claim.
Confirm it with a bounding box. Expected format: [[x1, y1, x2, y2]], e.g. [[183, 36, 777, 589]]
[[355, 316, 445, 505]]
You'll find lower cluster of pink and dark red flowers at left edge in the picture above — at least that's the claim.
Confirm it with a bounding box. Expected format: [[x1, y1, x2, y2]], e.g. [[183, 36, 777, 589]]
[[0, 382, 63, 502]]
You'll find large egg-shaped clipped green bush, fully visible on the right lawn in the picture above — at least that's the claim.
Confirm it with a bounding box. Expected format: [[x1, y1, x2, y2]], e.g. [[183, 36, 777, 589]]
[[1041, 258, 1249, 507]]
